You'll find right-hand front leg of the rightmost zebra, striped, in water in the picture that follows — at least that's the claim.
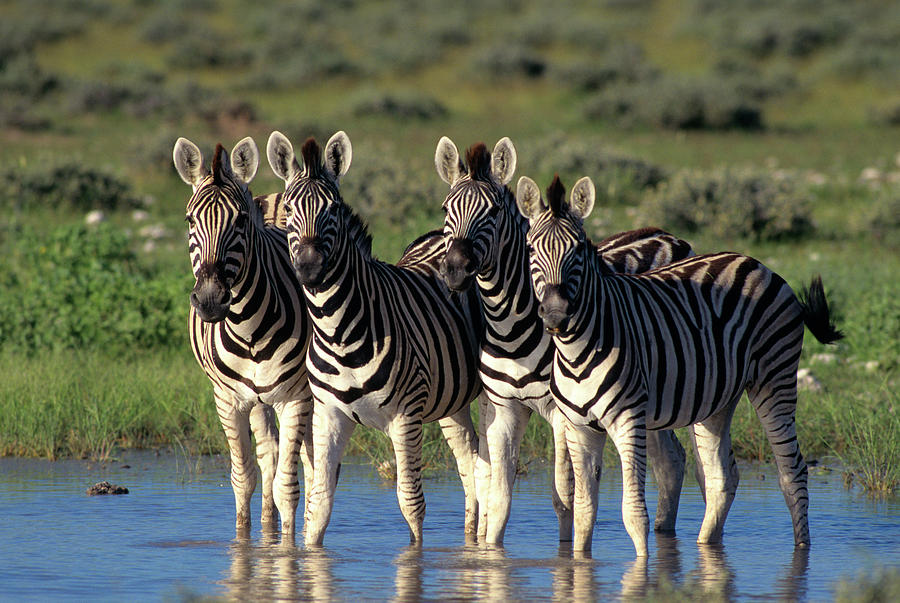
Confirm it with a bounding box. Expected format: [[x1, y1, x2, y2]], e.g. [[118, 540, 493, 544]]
[[609, 417, 650, 557]]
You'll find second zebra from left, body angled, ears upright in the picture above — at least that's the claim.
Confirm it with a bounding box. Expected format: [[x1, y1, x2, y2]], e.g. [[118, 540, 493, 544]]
[[266, 131, 483, 545]]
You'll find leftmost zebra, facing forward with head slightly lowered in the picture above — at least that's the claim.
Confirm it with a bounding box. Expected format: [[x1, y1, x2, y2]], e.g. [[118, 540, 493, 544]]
[[173, 137, 312, 538]]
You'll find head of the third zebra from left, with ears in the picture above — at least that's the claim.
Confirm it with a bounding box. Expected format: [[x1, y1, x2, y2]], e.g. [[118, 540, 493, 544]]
[[434, 136, 516, 291]]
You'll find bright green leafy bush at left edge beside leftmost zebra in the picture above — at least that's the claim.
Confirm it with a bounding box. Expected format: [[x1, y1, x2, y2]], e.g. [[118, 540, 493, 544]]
[[0, 223, 191, 353]]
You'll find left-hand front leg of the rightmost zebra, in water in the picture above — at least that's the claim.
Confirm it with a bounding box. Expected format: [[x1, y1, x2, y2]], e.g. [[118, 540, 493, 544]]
[[565, 422, 606, 551]]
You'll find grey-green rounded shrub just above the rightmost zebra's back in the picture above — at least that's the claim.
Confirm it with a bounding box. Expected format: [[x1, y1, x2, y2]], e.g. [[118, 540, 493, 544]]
[[642, 169, 813, 240]]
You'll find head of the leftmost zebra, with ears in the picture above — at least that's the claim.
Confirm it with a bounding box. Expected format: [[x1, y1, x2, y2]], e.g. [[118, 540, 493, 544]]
[[172, 137, 261, 322]]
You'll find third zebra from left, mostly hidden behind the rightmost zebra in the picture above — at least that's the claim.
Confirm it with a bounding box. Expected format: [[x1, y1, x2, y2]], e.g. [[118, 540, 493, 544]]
[[435, 136, 693, 544]]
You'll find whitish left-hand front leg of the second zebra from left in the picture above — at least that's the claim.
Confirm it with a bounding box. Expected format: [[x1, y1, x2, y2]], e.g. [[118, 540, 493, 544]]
[[304, 404, 356, 546]]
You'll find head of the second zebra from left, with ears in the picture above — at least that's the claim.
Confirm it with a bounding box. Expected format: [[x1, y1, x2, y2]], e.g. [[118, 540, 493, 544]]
[[266, 131, 353, 287]]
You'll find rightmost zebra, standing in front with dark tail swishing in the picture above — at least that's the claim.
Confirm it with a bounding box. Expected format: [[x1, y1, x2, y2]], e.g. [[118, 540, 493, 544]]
[[516, 176, 843, 556]]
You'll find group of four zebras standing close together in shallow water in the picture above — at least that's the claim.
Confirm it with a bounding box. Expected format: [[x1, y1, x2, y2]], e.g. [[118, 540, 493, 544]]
[[173, 132, 841, 556]]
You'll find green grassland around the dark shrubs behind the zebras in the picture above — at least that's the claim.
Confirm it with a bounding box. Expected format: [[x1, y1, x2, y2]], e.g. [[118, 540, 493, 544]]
[[0, 0, 900, 495]]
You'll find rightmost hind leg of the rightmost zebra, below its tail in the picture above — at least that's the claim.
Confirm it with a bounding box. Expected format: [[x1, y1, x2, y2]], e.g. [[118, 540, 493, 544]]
[[747, 378, 810, 546]]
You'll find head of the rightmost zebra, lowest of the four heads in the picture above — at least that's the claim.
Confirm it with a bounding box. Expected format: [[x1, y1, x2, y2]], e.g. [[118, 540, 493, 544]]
[[516, 176, 596, 335]]
